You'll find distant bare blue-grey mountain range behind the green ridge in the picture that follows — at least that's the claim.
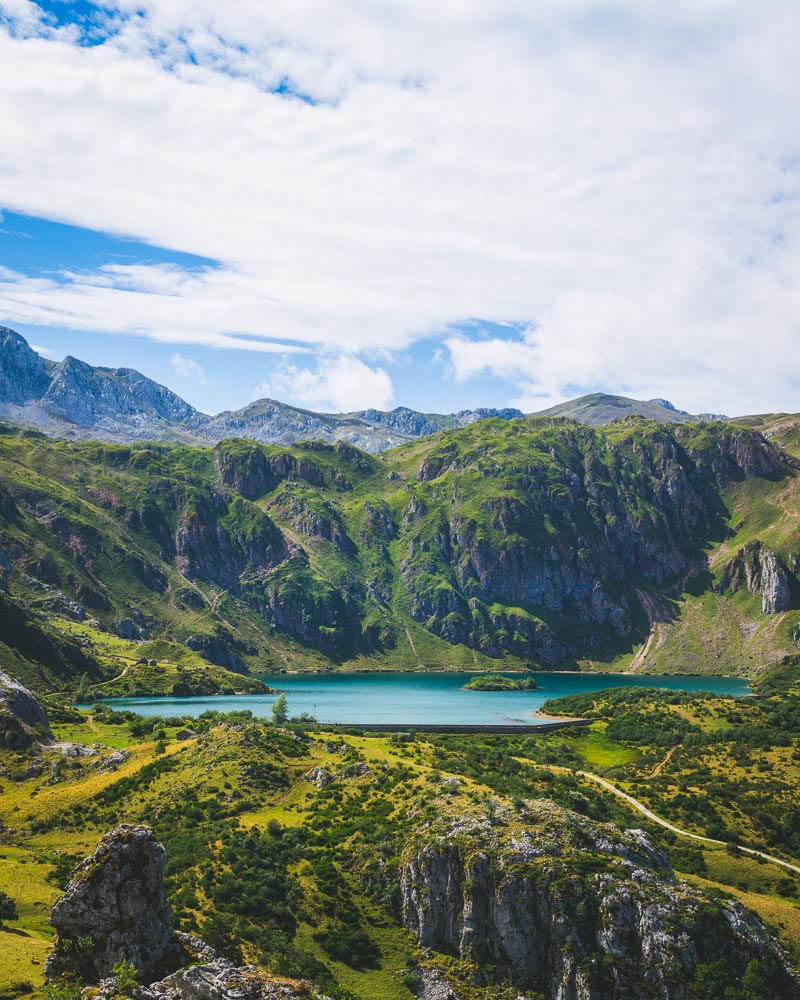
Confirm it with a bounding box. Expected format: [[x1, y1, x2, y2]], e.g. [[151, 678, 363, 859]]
[[0, 327, 721, 453]]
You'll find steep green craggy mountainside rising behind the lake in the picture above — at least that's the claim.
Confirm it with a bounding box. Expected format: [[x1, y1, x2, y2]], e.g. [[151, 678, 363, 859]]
[[0, 417, 800, 694]]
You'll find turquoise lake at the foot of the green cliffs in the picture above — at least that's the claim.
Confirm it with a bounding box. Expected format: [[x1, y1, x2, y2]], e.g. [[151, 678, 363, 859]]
[[101, 673, 750, 726]]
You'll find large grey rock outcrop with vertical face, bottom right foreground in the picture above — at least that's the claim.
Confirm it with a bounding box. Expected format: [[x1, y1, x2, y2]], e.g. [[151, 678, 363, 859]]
[[401, 801, 800, 1000]]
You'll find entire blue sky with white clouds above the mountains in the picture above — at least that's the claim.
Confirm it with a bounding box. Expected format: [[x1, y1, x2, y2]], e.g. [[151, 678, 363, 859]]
[[0, 0, 800, 415]]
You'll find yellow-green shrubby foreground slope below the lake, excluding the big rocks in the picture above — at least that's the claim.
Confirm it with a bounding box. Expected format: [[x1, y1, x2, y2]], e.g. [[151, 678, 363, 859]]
[[0, 689, 800, 1000]]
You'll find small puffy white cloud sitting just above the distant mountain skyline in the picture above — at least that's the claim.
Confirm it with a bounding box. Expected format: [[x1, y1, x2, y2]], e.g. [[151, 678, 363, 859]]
[[253, 355, 393, 413]]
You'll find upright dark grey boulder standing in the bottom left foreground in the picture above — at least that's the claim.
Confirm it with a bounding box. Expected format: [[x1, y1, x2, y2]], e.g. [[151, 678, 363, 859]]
[[47, 825, 181, 983]]
